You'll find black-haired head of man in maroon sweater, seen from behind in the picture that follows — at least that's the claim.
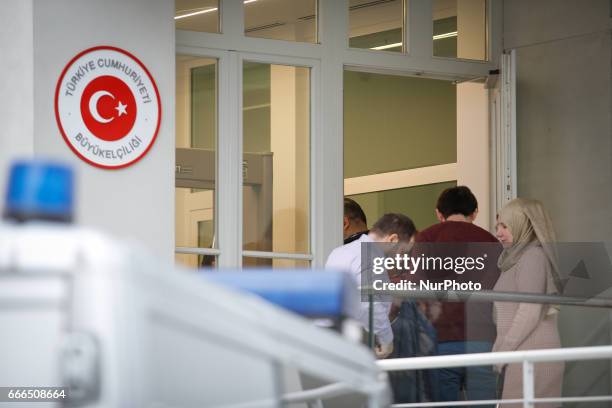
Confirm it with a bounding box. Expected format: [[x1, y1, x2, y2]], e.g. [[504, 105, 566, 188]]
[[436, 186, 478, 222]]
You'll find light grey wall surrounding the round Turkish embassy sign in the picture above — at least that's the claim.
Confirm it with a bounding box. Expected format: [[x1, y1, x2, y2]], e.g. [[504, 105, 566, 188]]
[[32, 0, 175, 261]]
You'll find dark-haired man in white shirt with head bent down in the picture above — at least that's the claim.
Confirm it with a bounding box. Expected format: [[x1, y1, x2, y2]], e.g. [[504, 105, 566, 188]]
[[325, 214, 416, 358]]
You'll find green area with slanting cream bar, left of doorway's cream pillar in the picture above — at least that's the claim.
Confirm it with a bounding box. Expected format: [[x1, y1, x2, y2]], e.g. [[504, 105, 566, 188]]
[[344, 71, 457, 229]]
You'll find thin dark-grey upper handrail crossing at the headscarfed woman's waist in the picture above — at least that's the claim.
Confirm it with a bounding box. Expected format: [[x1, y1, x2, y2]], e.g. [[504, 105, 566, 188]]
[[361, 287, 612, 308]]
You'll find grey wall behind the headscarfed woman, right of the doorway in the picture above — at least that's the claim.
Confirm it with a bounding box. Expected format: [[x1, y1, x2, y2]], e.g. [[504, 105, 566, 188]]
[[504, 0, 612, 396]]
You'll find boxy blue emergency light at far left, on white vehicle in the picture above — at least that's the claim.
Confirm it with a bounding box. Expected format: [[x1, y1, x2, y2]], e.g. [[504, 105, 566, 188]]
[[4, 160, 74, 222]]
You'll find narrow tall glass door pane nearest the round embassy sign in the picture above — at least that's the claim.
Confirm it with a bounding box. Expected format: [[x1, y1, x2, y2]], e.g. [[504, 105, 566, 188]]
[[175, 55, 219, 268]]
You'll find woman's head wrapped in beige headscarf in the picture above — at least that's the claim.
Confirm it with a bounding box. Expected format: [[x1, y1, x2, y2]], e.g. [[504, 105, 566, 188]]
[[495, 198, 554, 246]]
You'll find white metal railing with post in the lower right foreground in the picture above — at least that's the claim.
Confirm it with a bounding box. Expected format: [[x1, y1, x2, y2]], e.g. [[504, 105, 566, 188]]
[[378, 346, 612, 408]]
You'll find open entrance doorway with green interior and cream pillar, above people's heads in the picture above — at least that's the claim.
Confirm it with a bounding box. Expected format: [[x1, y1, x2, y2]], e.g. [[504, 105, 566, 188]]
[[344, 70, 491, 230]]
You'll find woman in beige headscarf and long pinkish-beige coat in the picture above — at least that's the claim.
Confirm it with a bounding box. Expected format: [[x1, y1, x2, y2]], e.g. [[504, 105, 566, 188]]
[[493, 198, 564, 407]]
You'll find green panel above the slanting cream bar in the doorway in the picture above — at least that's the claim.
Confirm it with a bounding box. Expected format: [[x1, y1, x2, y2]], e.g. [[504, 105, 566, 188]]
[[344, 71, 457, 178]]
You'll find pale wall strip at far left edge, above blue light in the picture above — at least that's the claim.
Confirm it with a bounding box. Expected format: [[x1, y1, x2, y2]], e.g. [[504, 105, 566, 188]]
[[0, 0, 34, 213]]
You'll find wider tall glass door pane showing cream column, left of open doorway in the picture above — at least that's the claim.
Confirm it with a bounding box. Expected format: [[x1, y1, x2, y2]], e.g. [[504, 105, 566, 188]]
[[241, 54, 316, 268]]
